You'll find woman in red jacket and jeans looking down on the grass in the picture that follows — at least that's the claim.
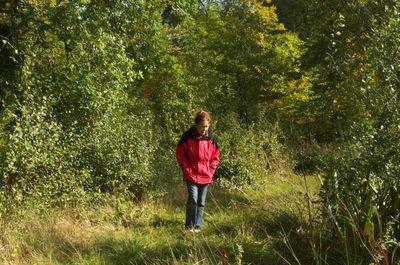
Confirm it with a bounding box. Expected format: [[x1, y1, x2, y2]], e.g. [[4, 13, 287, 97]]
[[176, 111, 220, 232]]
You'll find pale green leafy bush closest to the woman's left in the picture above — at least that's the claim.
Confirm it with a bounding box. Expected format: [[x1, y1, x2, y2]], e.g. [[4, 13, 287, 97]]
[[80, 100, 158, 198]]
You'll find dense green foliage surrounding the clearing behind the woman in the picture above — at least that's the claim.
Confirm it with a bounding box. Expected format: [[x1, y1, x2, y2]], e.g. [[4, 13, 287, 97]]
[[0, 0, 400, 264]]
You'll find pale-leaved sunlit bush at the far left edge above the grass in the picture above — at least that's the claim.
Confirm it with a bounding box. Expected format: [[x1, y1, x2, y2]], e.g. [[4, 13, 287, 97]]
[[1, 94, 89, 206]]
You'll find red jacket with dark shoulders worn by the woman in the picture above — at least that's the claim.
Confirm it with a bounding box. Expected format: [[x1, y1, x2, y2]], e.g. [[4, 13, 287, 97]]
[[176, 127, 219, 184]]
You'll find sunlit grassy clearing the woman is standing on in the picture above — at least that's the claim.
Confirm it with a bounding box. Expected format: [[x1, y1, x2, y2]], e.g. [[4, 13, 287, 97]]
[[0, 173, 317, 265]]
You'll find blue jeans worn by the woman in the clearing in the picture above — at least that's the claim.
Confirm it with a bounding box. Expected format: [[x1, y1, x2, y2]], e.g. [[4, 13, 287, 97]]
[[185, 181, 208, 228]]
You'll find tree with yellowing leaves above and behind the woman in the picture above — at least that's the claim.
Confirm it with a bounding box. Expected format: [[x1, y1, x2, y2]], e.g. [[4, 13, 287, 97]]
[[173, 1, 308, 124]]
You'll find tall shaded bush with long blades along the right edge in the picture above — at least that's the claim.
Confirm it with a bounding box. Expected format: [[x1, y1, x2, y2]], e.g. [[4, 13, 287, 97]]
[[321, 6, 400, 264]]
